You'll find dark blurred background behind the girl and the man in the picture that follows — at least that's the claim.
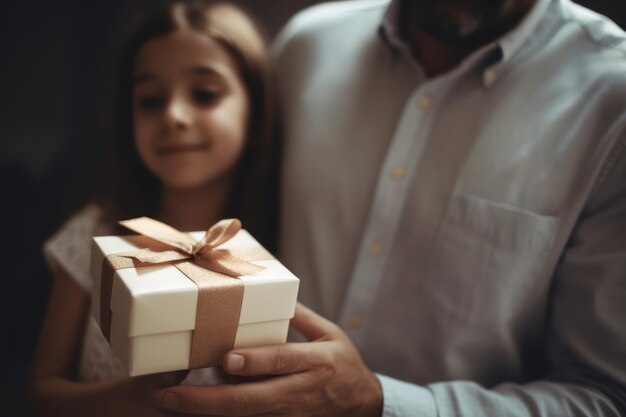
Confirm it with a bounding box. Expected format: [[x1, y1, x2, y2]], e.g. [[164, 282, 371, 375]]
[[0, 0, 626, 416]]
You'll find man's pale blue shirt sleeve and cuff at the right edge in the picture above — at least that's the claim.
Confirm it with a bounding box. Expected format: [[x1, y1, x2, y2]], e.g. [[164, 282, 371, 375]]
[[378, 134, 626, 417]]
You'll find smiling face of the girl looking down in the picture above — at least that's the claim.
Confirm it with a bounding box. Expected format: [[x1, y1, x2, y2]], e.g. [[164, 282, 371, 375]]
[[133, 29, 249, 189]]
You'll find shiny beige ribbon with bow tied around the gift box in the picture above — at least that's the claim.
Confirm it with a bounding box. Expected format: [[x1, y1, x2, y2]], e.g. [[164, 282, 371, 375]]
[[100, 217, 273, 369]]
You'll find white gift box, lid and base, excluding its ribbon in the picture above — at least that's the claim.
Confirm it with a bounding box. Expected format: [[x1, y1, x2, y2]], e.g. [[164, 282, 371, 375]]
[[91, 230, 299, 376]]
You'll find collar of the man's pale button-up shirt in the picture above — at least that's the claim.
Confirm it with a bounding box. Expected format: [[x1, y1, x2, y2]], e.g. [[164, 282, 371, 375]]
[[380, 0, 551, 87]]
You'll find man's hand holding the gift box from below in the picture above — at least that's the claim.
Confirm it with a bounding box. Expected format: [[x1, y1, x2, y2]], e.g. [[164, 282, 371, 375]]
[[157, 304, 382, 417]]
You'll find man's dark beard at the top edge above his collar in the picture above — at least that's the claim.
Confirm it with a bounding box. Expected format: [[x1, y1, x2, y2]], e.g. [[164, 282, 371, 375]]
[[402, 0, 520, 43]]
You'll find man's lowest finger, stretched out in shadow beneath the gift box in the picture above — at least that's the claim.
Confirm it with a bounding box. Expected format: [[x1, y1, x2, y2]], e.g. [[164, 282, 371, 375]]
[[157, 380, 287, 416]]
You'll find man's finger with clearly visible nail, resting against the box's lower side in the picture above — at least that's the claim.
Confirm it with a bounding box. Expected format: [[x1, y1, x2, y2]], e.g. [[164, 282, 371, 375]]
[[223, 343, 316, 376]]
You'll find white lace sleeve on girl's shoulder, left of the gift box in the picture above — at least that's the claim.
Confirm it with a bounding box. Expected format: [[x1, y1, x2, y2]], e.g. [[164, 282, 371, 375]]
[[43, 204, 113, 293]]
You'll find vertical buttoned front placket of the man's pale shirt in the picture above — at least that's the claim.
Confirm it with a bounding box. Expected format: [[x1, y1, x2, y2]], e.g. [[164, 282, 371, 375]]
[[339, 80, 444, 345]]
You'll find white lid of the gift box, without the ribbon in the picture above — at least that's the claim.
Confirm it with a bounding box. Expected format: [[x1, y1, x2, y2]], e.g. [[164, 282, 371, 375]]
[[91, 230, 299, 337]]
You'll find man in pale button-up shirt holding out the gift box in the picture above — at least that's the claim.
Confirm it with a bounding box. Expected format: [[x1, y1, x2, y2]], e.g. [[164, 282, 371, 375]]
[[154, 0, 626, 416]]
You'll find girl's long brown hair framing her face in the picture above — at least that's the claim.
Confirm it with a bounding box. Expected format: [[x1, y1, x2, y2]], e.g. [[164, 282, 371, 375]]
[[95, 2, 278, 250]]
